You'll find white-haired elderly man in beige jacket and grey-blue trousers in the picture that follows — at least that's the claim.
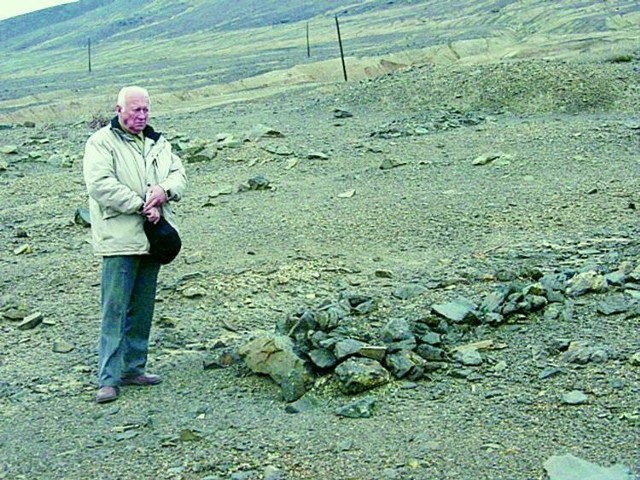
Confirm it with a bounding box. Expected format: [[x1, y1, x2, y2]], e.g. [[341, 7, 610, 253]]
[[83, 86, 187, 403]]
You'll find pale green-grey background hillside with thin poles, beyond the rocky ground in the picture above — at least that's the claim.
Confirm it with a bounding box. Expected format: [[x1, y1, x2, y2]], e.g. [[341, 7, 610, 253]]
[[0, 0, 640, 122]]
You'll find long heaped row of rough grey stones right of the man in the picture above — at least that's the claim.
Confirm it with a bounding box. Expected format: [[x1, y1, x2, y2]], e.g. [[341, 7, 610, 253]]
[[239, 263, 640, 402]]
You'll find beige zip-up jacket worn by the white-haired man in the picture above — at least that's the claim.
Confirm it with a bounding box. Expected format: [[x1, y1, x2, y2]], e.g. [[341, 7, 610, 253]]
[[83, 117, 187, 256]]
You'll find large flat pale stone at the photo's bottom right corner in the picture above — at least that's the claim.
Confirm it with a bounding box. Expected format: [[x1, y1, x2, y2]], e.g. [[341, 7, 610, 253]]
[[544, 454, 634, 480]]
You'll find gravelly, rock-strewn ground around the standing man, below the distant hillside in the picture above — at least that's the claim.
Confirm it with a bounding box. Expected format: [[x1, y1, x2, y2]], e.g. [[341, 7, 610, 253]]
[[0, 58, 640, 480]]
